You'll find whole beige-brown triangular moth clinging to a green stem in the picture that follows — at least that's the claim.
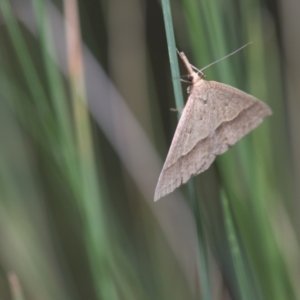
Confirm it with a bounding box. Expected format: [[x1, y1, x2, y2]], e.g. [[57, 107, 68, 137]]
[[154, 51, 272, 201]]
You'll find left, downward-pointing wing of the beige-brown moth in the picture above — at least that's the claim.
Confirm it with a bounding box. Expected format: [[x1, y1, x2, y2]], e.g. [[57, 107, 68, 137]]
[[154, 80, 214, 201]]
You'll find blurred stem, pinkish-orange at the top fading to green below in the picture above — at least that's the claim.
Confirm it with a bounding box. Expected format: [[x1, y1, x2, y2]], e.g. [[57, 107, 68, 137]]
[[64, 0, 118, 300]]
